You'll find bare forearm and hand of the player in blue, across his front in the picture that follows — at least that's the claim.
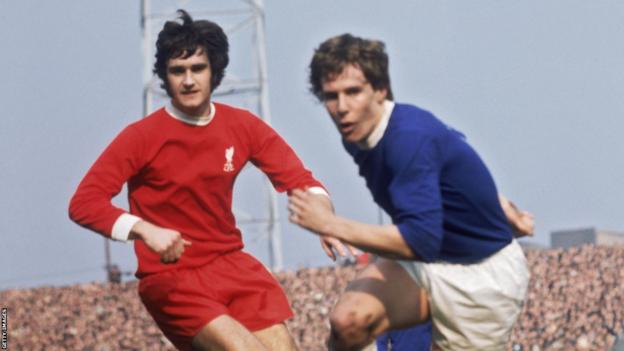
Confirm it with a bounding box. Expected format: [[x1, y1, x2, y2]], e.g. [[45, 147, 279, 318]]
[[288, 190, 417, 259]]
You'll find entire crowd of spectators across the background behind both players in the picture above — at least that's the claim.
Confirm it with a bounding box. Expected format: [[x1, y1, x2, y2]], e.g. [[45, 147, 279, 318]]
[[0, 246, 624, 351]]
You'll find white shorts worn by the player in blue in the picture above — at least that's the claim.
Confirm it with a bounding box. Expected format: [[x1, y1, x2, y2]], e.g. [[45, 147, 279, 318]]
[[399, 240, 529, 351]]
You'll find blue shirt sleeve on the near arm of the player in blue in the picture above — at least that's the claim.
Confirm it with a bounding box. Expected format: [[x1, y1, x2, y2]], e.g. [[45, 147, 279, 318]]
[[387, 133, 444, 262]]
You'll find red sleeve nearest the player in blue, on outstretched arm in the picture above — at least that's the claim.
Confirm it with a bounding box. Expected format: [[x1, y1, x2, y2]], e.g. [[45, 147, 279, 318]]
[[251, 117, 327, 193]]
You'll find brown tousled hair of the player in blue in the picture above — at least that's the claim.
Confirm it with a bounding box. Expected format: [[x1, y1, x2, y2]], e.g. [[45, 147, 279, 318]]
[[309, 33, 394, 101]]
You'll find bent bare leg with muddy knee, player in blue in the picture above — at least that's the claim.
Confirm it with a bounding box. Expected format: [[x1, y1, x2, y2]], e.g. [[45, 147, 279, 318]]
[[328, 259, 429, 350]]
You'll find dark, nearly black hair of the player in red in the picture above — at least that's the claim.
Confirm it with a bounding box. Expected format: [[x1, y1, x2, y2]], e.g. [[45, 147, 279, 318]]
[[154, 10, 230, 96]]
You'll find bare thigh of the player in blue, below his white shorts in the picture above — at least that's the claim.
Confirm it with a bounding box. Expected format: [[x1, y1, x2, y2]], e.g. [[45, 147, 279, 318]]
[[334, 259, 429, 335]]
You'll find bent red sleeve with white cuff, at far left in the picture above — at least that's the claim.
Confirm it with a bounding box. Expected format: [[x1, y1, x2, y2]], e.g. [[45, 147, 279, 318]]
[[69, 126, 143, 240]]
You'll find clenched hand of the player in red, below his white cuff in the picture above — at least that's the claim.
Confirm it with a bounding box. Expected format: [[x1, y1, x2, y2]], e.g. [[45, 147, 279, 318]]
[[131, 221, 191, 263]]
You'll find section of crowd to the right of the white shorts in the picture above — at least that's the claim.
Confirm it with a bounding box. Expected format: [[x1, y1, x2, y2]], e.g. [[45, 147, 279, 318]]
[[512, 245, 624, 351]]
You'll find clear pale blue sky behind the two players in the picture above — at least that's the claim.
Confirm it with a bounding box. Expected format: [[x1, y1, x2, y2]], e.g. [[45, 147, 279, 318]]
[[0, 0, 624, 290]]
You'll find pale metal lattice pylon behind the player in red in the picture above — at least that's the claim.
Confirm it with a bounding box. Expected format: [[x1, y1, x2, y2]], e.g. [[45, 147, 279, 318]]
[[141, 0, 283, 271]]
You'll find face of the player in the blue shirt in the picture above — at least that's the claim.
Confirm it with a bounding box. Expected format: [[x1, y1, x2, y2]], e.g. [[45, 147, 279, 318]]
[[322, 65, 386, 143]]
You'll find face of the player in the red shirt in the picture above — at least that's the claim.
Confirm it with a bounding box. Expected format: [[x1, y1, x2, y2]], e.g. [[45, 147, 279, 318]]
[[167, 49, 212, 116]]
